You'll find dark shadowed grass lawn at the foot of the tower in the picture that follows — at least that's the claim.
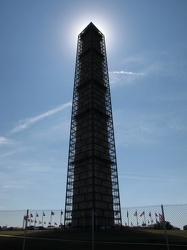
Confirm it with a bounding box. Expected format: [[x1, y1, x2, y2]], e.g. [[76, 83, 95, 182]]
[[0, 228, 187, 250]]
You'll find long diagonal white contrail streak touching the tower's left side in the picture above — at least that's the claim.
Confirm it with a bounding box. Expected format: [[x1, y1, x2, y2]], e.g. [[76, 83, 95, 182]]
[[11, 102, 71, 133]]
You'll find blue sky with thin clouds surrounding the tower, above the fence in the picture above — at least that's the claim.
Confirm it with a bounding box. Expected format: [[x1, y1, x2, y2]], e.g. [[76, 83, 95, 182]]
[[0, 0, 187, 210]]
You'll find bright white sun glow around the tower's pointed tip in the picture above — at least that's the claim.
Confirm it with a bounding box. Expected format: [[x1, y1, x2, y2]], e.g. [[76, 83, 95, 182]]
[[59, 10, 117, 58]]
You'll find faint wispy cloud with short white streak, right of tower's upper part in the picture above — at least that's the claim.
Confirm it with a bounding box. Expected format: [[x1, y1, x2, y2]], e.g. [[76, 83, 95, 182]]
[[109, 51, 179, 86]]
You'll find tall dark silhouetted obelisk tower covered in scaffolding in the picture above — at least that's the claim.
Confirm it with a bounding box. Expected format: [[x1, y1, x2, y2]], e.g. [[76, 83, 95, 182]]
[[64, 23, 121, 228]]
